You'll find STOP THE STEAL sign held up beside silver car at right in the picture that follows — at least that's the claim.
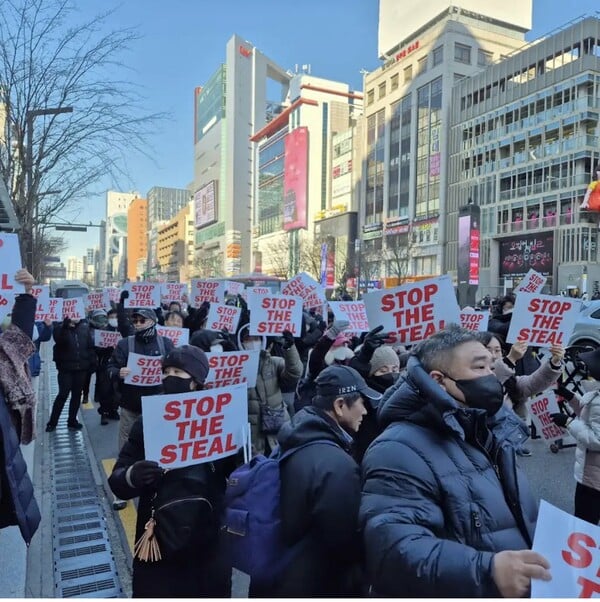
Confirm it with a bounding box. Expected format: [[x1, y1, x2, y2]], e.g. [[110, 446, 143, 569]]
[[506, 293, 581, 347]]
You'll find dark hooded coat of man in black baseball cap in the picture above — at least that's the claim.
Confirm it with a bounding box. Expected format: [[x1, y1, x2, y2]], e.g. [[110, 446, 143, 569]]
[[251, 407, 361, 598]]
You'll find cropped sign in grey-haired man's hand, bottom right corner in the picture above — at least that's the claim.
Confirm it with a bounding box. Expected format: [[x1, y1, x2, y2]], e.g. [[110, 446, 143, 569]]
[[531, 500, 600, 599]]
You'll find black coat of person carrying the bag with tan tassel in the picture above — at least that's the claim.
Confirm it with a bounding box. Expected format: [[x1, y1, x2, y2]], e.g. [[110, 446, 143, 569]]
[[108, 416, 231, 598]]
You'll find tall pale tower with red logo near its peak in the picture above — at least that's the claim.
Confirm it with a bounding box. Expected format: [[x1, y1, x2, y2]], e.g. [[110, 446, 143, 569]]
[[193, 35, 290, 276]]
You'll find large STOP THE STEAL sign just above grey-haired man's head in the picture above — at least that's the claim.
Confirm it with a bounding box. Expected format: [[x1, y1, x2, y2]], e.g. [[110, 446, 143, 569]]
[[363, 276, 460, 343]]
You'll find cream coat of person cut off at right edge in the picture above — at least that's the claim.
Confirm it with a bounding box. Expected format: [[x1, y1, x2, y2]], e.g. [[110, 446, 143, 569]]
[[567, 391, 600, 491]]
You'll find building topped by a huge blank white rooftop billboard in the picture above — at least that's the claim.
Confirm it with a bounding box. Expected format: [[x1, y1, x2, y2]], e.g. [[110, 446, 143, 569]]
[[358, 0, 532, 286]]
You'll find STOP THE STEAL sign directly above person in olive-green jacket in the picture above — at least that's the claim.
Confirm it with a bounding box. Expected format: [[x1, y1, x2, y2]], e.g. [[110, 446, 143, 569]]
[[248, 294, 302, 337]]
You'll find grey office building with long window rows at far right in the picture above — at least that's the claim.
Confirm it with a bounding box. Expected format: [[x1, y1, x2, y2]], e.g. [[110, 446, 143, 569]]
[[445, 17, 600, 296]]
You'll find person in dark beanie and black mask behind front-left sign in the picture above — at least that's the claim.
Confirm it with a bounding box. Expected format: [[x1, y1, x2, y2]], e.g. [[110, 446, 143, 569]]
[[108, 345, 233, 598]]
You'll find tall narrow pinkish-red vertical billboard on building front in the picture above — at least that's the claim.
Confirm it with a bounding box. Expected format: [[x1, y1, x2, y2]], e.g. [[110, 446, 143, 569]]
[[283, 127, 308, 232]]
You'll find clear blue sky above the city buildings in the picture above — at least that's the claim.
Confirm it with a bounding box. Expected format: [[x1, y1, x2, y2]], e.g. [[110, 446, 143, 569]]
[[62, 0, 600, 260]]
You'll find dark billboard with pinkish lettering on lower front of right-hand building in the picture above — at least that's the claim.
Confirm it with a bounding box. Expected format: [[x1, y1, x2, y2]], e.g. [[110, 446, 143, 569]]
[[500, 232, 554, 277]]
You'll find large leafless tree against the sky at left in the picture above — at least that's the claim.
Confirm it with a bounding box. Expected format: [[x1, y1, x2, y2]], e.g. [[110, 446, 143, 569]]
[[0, 0, 164, 275]]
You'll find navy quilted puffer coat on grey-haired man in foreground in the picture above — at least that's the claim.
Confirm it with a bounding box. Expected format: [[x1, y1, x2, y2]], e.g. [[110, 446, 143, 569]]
[[360, 357, 537, 598]]
